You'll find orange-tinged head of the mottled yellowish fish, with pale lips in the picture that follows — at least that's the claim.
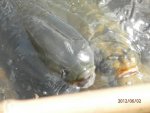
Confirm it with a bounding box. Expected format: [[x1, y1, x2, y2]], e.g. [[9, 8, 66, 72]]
[[112, 47, 144, 86]]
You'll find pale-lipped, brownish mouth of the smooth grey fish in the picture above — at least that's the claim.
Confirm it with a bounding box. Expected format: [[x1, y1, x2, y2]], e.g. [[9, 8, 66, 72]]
[[73, 68, 96, 88]]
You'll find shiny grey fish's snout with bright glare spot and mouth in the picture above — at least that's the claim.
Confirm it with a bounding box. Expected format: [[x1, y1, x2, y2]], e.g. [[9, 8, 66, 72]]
[[65, 46, 95, 88]]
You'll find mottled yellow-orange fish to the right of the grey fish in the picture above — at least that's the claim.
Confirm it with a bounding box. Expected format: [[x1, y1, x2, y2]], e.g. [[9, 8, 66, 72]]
[[33, 0, 150, 86]]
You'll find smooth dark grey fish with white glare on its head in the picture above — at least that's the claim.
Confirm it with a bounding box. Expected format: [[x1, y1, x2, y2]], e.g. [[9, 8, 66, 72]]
[[12, 0, 95, 88]]
